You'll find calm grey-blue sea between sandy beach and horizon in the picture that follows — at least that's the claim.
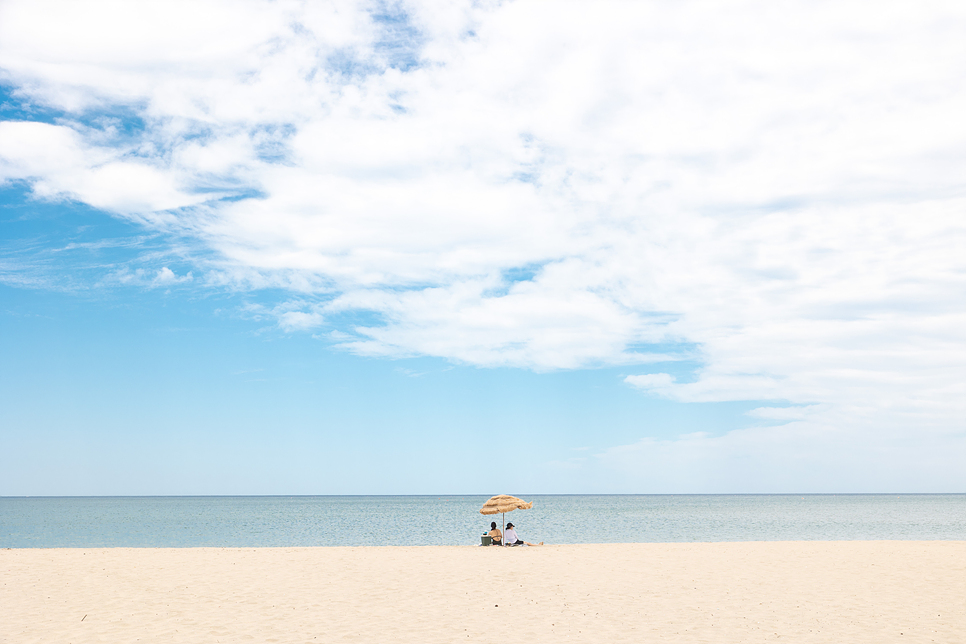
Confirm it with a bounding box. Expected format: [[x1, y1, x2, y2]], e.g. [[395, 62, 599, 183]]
[[0, 494, 966, 548]]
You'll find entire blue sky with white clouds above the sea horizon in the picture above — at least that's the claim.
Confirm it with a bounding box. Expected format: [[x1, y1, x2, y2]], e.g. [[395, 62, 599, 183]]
[[0, 0, 966, 495]]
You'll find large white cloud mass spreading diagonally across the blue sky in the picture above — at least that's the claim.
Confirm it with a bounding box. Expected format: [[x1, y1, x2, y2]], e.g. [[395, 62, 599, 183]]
[[0, 2, 966, 484]]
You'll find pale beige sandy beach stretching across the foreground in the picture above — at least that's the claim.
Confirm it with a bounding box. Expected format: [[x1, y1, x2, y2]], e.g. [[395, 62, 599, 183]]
[[0, 541, 966, 644]]
